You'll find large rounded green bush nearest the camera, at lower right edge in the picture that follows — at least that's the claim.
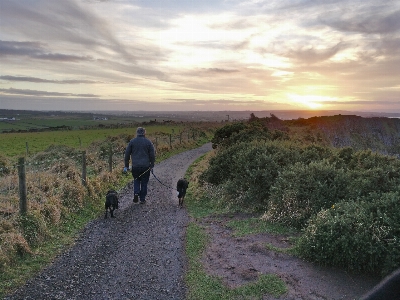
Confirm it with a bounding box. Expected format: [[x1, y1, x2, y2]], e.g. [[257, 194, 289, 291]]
[[297, 192, 400, 276]]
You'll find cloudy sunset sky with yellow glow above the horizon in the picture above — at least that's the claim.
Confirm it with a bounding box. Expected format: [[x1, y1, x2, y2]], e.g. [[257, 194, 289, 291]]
[[0, 0, 400, 113]]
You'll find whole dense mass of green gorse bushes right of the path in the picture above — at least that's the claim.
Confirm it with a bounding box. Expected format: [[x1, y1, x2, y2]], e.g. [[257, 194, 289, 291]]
[[201, 118, 400, 275]]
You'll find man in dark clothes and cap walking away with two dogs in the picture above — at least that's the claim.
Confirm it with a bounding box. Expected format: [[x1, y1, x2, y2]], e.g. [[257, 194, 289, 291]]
[[124, 127, 155, 204]]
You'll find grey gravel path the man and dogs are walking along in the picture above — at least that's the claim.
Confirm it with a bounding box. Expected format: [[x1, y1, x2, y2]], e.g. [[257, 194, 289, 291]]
[[5, 144, 211, 300]]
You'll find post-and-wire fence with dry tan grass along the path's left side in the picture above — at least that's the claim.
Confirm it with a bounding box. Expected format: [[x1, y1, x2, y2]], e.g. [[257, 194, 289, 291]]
[[0, 131, 200, 221]]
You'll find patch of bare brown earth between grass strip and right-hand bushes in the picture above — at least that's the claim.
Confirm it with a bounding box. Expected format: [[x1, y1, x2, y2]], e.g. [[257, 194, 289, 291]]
[[201, 216, 379, 300]]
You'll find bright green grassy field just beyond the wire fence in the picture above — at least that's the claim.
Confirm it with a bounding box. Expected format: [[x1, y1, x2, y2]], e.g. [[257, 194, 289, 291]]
[[0, 124, 187, 157]]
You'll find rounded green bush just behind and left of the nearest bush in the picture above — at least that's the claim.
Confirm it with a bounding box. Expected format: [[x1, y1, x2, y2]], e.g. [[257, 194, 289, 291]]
[[265, 160, 348, 228]]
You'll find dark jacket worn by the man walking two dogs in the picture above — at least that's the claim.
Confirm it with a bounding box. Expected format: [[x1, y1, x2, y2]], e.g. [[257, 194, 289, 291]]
[[124, 135, 156, 168]]
